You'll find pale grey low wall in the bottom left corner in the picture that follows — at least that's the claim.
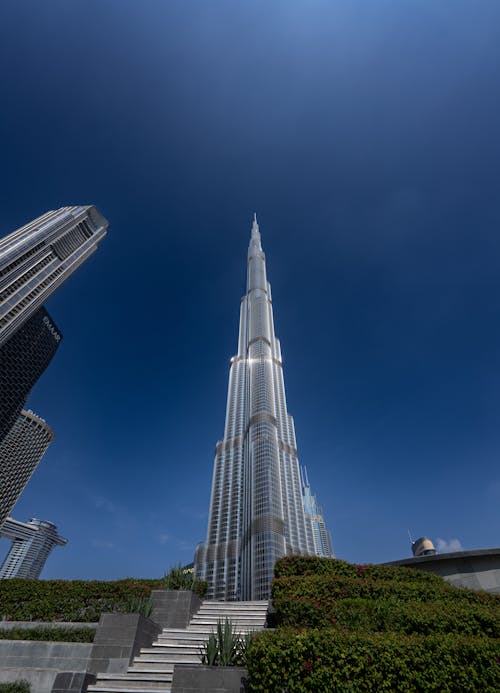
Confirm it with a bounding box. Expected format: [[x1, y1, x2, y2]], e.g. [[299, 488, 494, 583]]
[[0, 640, 92, 693]]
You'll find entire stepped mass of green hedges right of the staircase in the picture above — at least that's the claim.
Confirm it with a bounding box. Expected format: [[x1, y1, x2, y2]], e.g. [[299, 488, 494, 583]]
[[247, 556, 500, 693]]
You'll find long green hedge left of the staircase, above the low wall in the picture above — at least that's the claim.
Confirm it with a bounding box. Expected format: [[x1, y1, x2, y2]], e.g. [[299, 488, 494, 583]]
[[0, 578, 163, 622]]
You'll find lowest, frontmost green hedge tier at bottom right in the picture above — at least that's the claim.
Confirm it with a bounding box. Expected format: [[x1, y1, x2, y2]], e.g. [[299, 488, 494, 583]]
[[247, 629, 500, 693]]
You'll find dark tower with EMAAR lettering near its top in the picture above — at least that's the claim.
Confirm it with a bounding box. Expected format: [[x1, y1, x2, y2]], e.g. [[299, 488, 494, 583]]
[[0, 306, 62, 443]]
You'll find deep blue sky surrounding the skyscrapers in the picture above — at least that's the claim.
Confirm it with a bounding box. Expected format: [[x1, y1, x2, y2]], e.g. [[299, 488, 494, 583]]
[[0, 0, 500, 578]]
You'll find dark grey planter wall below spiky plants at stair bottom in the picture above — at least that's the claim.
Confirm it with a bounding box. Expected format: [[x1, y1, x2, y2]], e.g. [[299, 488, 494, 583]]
[[171, 664, 248, 693]]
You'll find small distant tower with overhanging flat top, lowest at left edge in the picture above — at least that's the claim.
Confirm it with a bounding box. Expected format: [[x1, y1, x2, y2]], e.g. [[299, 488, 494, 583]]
[[0, 517, 68, 580]]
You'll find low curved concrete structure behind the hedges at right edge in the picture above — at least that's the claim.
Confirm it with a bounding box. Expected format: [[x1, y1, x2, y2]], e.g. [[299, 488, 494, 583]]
[[387, 549, 500, 593]]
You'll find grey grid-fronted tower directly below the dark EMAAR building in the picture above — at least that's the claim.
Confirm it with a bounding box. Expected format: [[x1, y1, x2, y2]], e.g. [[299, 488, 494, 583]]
[[0, 409, 54, 528]]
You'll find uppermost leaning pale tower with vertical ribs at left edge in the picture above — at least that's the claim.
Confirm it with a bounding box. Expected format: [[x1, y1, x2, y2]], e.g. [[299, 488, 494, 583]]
[[0, 206, 108, 346]]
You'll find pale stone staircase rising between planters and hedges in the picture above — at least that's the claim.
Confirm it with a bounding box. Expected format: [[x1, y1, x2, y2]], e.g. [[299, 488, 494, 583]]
[[88, 601, 268, 693]]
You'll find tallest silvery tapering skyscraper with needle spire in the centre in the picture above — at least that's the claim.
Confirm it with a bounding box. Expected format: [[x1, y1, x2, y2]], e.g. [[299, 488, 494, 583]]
[[196, 217, 332, 600]]
